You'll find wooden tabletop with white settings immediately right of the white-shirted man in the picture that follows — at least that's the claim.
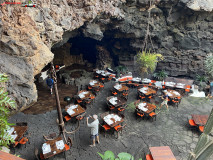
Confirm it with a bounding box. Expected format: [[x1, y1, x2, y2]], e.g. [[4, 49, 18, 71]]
[[103, 113, 124, 127]]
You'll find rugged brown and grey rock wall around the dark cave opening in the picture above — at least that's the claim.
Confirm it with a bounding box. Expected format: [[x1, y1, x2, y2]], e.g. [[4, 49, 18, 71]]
[[0, 0, 213, 110]]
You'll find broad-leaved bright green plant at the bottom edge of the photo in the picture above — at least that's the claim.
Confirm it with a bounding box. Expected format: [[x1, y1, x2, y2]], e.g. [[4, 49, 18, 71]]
[[98, 151, 142, 160]]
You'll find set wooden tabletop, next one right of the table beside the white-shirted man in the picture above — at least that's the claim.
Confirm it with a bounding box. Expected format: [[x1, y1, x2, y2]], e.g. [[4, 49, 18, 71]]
[[136, 102, 156, 114]]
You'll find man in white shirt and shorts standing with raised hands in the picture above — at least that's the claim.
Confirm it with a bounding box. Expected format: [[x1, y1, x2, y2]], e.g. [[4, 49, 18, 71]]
[[87, 115, 100, 147]]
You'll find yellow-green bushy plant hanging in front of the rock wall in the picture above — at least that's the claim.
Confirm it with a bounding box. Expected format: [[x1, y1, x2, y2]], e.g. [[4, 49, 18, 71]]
[[137, 50, 163, 73]]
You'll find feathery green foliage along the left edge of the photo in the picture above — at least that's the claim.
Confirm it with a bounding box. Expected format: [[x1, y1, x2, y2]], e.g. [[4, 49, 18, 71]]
[[0, 74, 16, 149]]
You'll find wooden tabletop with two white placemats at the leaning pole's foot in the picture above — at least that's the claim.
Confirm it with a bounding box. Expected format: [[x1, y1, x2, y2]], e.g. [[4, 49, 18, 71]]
[[42, 137, 66, 159]]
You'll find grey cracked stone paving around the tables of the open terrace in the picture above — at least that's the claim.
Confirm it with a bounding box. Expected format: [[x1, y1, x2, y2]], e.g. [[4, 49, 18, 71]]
[[10, 82, 213, 160]]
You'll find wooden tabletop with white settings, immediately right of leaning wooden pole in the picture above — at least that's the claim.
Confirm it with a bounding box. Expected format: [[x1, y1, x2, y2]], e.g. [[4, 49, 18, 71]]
[[65, 104, 86, 117]]
